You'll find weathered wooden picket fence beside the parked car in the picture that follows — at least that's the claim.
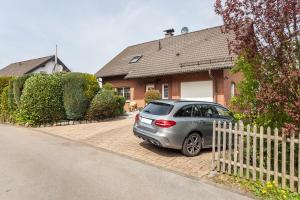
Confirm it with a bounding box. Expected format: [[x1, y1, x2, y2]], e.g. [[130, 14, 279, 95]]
[[212, 122, 300, 193]]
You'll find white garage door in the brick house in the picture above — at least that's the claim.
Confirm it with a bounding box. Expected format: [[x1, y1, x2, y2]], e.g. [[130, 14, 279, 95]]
[[181, 81, 213, 102]]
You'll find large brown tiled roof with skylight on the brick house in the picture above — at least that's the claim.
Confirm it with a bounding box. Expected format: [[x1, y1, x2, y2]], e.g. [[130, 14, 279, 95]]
[[96, 26, 234, 78]]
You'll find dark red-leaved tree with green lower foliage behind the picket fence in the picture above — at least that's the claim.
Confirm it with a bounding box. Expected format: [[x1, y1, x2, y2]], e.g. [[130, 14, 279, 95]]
[[215, 0, 300, 134]]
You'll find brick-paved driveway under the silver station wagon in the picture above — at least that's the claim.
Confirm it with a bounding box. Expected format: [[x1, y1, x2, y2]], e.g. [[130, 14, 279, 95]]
[[36, 117, 211, 178]]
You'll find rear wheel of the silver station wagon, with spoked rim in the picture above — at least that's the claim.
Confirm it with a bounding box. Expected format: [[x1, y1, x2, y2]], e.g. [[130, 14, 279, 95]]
[[181, 133, 202, 157]]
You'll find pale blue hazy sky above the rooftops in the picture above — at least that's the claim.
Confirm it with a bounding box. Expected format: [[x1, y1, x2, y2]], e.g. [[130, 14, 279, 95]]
[[0, 0, 222, 73]]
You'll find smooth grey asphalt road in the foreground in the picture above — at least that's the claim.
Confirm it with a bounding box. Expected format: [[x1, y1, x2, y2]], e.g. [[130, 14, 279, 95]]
[[0, 125, 253, 200]]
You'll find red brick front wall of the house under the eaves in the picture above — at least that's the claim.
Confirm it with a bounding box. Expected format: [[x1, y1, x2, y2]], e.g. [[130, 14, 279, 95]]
[[103, 70, 242, 107]]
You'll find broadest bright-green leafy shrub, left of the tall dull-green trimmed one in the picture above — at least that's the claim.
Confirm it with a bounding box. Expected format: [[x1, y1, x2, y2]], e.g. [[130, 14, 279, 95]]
[[17, 74, 64, 125]]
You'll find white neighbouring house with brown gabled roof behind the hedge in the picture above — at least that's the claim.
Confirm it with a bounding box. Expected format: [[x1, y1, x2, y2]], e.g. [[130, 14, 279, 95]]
[[0, 55, 70, 76]]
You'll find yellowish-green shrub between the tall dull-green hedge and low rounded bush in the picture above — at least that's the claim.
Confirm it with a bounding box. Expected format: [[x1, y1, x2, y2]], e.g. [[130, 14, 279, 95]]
[[82, 74, 100, 101]]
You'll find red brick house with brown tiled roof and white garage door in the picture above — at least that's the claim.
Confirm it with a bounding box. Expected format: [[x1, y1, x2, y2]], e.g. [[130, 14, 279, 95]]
[[96, 26, 242, 107]]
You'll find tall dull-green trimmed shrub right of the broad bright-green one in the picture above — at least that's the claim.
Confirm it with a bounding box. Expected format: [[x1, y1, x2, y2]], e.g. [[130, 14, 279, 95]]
[[63, 73, 89, 120]]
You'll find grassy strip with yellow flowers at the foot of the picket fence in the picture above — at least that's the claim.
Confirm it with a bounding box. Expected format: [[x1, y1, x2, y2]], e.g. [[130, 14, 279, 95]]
[[213, 174, 300, 200]]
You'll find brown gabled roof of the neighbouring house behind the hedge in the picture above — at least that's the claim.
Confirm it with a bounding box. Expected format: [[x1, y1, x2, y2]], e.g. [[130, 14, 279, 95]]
[[0, 55, 70, 76]]
